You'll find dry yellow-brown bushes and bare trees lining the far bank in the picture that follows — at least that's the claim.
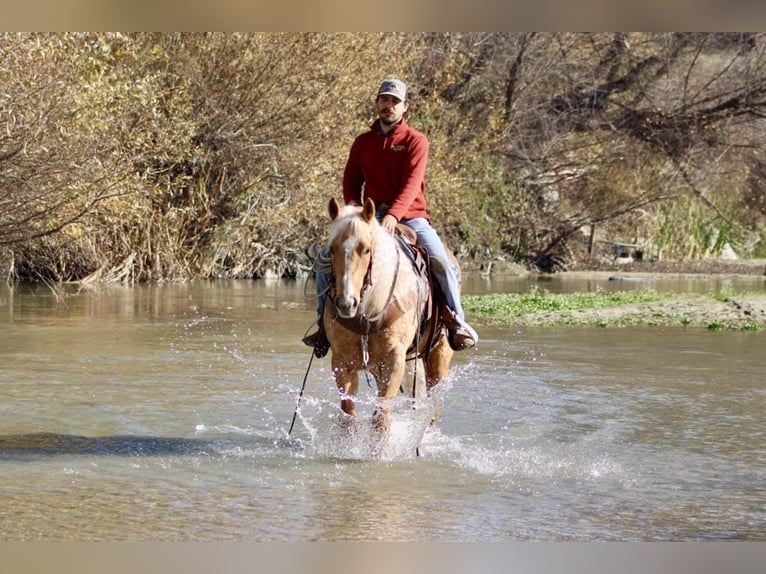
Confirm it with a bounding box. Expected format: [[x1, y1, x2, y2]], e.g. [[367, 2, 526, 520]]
[[0, 33, 766, 284]]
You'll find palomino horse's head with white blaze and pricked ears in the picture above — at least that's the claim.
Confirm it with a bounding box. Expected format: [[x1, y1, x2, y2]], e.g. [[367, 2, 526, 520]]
[[328, 197, 378, 318]]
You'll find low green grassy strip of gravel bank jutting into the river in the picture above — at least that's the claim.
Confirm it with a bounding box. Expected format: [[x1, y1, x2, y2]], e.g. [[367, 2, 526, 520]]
[[463, 289, 766, 331]]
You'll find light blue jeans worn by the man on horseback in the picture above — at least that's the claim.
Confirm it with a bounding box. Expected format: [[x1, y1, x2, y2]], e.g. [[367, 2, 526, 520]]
[[314, 217, 465, 321]]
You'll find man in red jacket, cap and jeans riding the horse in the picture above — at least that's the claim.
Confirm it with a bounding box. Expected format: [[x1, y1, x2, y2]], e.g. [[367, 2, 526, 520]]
[[303, 79, 479, 357]]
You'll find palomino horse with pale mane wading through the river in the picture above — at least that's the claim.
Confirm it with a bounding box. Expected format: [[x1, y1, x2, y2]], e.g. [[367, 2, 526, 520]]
[[323, 198, 453, 446]]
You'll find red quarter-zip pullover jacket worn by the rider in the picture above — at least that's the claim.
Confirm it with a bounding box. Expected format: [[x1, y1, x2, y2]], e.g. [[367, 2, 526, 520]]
[[343, 118, 430, 221]]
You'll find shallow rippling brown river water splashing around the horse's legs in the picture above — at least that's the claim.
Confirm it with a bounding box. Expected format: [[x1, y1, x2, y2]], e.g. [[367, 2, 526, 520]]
[[0, 277, 766, 541]]
